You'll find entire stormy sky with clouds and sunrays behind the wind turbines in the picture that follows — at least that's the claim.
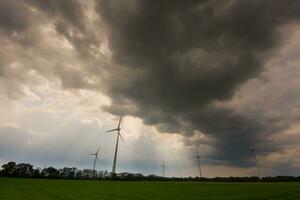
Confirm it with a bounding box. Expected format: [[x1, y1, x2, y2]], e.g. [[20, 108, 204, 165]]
[[0, 0, 300, 177]]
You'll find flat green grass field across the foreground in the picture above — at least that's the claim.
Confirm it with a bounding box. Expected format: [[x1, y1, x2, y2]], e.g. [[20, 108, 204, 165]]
[[0, 178, 300, 200]]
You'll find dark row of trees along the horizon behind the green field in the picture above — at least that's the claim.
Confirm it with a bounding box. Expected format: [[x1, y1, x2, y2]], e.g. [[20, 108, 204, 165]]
[[0, 162, 300, 182]]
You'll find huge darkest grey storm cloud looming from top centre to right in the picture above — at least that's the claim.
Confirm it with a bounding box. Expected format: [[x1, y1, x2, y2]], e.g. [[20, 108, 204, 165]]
[[96, 0, 300, 165]]
